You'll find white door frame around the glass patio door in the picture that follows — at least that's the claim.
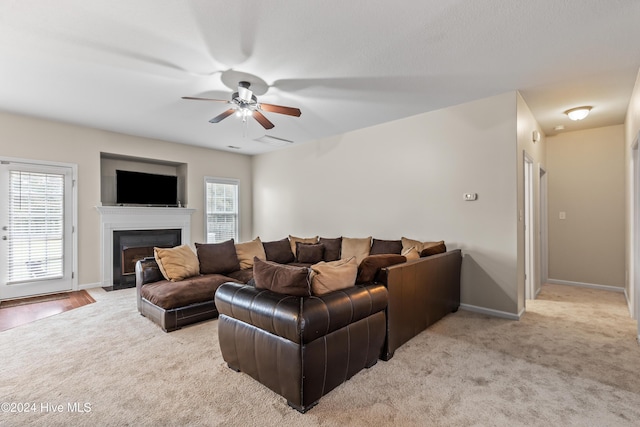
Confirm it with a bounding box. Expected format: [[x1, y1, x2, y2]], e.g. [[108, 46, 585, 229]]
[[0, 156, 78, 300]]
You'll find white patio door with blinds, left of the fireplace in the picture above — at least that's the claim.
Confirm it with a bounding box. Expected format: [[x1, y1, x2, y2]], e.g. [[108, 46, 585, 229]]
[[0, 161, 73, 300]]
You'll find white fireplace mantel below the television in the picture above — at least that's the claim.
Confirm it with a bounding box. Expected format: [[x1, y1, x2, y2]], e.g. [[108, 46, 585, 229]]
[[96, 206, 195, 287]]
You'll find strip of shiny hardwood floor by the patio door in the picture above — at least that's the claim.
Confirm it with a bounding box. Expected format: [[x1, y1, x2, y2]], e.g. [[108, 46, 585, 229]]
[[0, 290, 95, 332]]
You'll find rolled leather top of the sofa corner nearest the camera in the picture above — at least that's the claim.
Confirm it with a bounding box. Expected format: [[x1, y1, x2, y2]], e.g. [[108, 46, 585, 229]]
[[215, 283, 387, 344]]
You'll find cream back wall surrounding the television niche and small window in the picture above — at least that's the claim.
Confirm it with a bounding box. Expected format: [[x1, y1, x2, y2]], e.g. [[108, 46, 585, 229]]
[[0, 113, 252, 287]]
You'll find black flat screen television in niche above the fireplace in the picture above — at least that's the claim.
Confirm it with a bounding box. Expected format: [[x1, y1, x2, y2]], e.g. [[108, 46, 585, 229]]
[[116, 170, 178, 206]]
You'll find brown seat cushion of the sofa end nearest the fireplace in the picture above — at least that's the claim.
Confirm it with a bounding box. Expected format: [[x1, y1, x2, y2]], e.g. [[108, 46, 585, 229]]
[[140, 274, 237, 310]]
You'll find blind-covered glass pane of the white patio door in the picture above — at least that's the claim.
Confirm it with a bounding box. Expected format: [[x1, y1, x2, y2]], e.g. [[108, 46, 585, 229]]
[[8, 171, 64, 283]]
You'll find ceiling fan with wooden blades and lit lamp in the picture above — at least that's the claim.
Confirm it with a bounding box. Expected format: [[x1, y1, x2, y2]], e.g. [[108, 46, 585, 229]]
[[182, 81, 302, 129]]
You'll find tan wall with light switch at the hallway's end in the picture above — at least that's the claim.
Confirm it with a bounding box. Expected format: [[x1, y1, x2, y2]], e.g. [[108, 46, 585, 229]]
[[547, 125, 625, 287]]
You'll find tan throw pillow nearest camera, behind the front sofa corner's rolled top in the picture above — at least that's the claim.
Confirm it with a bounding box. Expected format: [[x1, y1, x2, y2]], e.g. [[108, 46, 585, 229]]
[[311, 257, 358, 295]]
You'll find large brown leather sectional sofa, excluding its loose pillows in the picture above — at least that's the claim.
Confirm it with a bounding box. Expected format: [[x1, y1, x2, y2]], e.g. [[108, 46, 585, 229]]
[[136, 241, 462, 412]]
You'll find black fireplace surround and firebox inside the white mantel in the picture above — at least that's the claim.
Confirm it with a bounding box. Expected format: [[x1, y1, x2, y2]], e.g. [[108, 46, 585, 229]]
[[109, 229, 182, 291]]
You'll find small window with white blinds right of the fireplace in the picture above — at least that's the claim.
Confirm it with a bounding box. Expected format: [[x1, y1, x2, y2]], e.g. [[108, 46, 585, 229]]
[[205, 177, 239, 243]]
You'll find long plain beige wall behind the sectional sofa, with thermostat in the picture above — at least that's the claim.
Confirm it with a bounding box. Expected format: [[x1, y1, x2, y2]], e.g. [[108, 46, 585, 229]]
[[253, 92, 522, 314]]
